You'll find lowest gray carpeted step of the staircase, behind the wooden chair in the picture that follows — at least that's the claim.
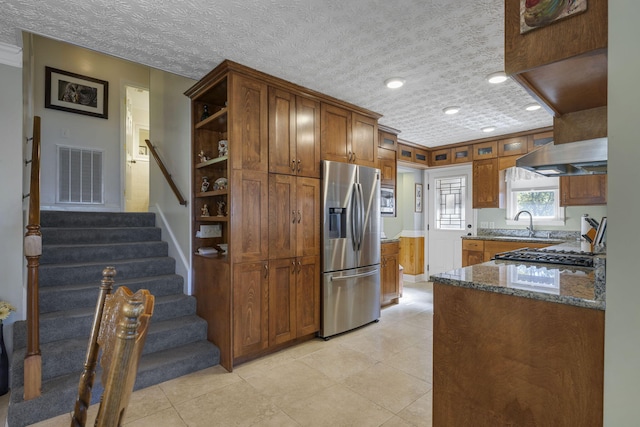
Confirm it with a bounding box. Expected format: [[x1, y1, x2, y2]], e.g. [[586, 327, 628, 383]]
[[7, 341, 220, 427]]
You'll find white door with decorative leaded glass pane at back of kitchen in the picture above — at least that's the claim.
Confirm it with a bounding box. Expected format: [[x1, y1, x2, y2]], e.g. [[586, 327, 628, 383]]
[[427, 165, 475, 275]]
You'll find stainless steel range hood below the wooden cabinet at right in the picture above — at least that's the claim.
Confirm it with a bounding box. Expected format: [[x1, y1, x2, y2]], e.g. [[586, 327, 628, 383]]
[[516, 138, 607, 176]]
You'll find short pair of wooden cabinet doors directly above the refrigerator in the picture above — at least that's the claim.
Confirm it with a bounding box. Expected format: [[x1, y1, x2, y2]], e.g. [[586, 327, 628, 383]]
[[320, 103, 378, 167]]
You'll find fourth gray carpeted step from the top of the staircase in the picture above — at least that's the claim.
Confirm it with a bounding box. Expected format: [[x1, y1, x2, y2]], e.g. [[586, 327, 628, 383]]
[[39, 257, 175, 287]]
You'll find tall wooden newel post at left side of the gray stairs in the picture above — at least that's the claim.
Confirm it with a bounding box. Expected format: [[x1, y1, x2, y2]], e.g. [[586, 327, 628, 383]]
[[24, 116, 42, 400]]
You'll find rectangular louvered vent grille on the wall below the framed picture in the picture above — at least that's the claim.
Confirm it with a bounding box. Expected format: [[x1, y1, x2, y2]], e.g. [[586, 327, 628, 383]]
[[58, 146, 103, 204]]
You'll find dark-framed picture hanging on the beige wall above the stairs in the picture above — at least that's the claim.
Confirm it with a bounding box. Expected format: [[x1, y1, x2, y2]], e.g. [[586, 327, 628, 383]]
[[44, 67, 109, 119]]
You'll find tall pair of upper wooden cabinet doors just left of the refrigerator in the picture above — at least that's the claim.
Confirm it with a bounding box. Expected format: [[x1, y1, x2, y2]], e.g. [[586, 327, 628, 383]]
[[269, 87, 321, 178]]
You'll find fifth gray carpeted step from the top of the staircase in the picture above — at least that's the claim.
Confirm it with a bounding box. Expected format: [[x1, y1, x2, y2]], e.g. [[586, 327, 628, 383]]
[[40, 274, 184, 313]]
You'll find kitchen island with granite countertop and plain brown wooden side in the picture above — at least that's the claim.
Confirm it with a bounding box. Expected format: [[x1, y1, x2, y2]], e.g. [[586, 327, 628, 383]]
[[431, 244, 605, 427]]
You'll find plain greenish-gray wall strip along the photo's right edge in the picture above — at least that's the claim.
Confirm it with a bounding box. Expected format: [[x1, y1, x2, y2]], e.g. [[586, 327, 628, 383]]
[[604, 0, 640, 427]]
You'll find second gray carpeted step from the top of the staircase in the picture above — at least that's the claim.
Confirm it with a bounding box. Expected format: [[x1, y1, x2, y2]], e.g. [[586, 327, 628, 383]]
[[40, 227, 162, 245]]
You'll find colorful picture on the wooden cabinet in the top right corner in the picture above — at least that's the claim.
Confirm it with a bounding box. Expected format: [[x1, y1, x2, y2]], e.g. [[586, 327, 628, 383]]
[[520, 0, 587, 34]]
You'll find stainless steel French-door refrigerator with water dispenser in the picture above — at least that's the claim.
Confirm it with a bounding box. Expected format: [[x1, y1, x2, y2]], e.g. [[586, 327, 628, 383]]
[[320, 160, 380, 338]]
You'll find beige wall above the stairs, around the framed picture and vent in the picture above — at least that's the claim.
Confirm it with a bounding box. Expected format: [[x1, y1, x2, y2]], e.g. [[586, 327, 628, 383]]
[[30, 35, 149, 211]]
